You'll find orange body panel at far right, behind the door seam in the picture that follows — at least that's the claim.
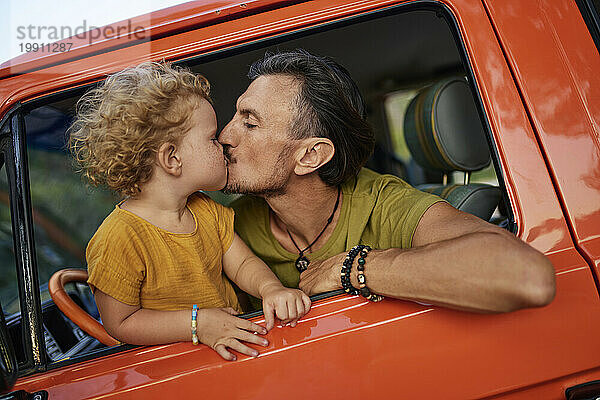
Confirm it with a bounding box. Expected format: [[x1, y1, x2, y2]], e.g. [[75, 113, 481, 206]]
[[480, 0, 600, 300]]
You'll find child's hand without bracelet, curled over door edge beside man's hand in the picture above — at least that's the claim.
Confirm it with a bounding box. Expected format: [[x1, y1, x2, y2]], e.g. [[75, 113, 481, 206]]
[[261, 283, 310, 331]]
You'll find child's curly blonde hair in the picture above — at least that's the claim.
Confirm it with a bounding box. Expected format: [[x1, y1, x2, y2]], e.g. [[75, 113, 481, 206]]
[[68, 62, 211, 196]]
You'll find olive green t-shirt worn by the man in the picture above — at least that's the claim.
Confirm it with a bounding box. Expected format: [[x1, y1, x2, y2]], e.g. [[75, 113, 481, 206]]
[[231, 168, 443, 304]]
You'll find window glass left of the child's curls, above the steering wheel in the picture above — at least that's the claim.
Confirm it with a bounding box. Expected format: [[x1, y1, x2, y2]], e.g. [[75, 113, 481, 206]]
[[25, 101, 117, 290]]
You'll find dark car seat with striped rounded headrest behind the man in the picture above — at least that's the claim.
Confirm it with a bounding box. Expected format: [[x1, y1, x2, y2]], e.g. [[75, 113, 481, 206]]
[[404, 77, 502, 221]]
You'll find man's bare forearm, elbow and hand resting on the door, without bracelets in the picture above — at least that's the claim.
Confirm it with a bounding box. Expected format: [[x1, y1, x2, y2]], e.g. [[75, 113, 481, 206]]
[[300, 203, 555, 312]]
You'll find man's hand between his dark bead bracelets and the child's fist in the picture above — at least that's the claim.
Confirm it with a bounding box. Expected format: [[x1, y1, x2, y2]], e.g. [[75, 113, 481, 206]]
[[298, 253, 346, 296]]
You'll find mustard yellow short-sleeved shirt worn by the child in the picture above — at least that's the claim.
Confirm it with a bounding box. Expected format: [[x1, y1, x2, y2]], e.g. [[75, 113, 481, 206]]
[[86, 193, 241, 311]]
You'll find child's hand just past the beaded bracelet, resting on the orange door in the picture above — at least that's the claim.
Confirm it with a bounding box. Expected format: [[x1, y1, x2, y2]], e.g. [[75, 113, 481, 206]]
[[197, 307, 269, 361]]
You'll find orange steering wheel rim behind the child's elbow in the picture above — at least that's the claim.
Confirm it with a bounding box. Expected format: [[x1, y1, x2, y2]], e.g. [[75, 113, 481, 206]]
[[48, 268, 120, 346]]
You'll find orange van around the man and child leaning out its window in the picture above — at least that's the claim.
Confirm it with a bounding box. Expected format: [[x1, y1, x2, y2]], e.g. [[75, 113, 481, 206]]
[[0, 0, 600, 399]]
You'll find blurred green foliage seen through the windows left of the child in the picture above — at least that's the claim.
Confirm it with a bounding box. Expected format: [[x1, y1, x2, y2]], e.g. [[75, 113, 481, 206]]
[[0, 150, 118, 314]]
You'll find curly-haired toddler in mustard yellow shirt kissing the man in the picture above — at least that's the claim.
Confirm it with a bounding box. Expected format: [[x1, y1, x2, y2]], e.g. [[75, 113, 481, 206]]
[[69, 62, 310, 360]]
